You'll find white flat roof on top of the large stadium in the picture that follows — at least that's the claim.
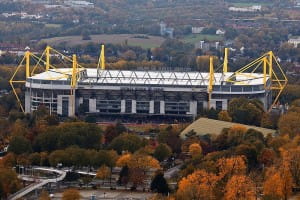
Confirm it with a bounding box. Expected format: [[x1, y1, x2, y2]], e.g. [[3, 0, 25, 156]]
[[30, 68, 268, 86]]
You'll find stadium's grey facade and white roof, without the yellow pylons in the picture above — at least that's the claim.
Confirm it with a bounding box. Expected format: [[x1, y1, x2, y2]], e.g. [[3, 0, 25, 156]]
[[25, 68, 272, 116]]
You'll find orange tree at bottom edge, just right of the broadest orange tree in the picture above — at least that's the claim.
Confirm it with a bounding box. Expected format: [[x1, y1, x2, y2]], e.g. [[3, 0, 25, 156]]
[[224, 175, 256, 200]]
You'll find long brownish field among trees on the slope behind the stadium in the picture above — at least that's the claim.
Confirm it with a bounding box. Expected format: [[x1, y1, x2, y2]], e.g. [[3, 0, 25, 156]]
[[41, 34, 165, 49]]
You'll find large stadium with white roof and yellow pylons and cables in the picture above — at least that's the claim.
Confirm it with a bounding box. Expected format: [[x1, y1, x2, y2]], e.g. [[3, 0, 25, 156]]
[[10, 46, 287, 118]]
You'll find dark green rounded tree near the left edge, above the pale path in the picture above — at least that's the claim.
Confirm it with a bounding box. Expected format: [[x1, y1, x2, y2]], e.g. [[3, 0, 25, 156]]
[[8, 136, 32, 154]]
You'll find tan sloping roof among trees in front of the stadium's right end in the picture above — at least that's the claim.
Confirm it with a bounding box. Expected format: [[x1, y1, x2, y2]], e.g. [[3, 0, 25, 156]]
[[181, 118, 276, 138]]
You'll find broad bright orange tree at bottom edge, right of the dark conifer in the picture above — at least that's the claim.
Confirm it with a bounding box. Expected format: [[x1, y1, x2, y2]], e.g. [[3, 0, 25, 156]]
[[176, 170, 219, 200]]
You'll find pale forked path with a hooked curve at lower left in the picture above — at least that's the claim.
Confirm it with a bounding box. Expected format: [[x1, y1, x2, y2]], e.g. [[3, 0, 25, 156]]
[[8, 167, 66, 200]]
